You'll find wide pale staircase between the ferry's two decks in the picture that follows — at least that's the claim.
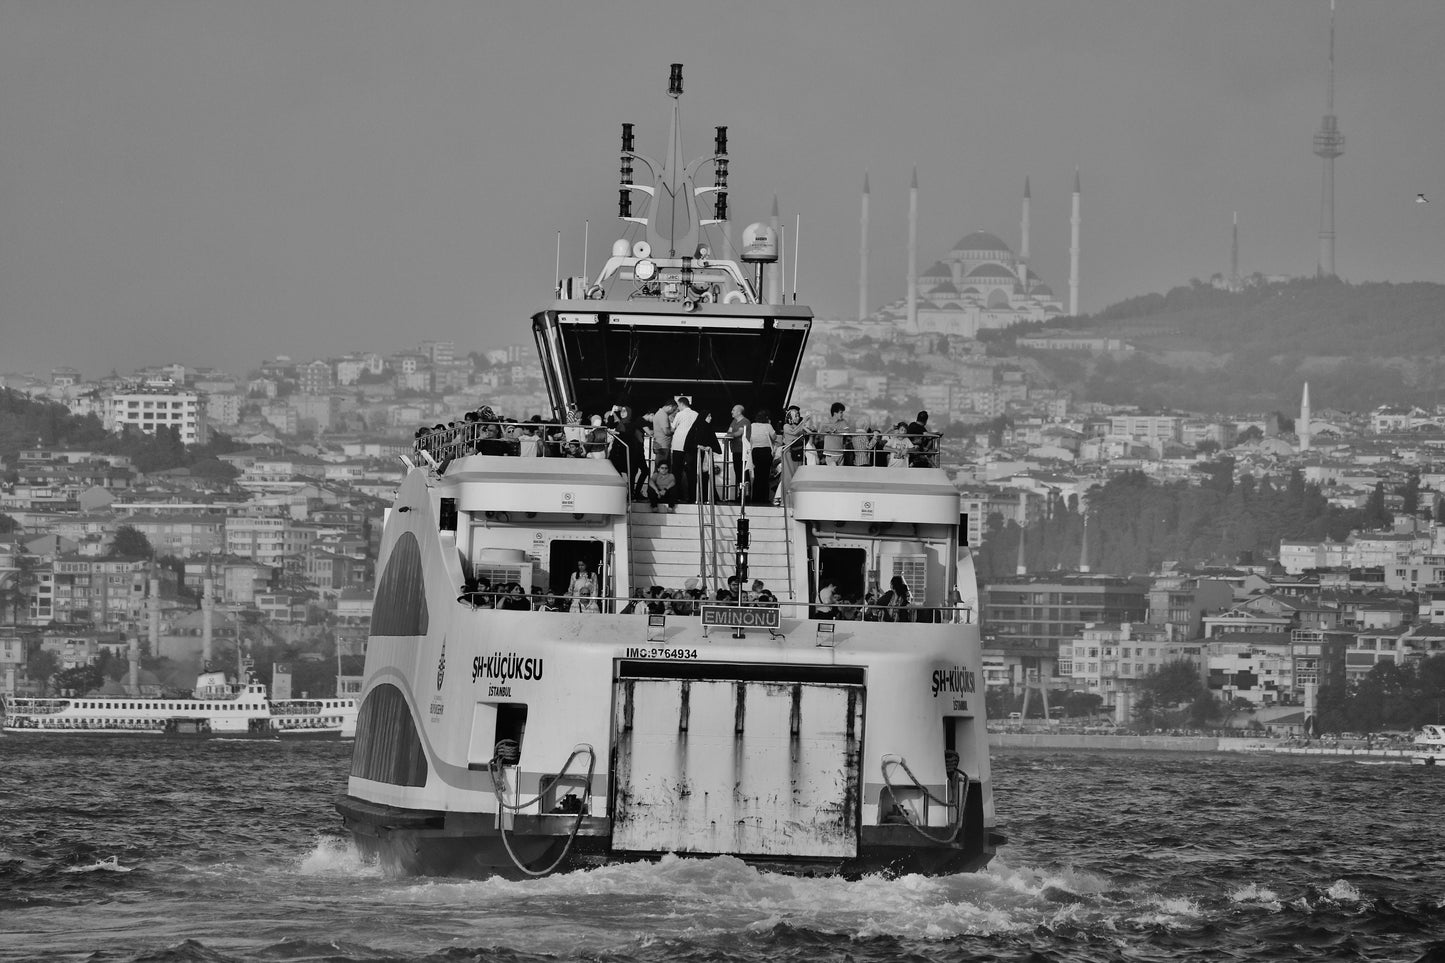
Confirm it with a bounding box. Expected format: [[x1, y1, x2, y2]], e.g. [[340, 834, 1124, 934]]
[[631, 505, 799, 602]]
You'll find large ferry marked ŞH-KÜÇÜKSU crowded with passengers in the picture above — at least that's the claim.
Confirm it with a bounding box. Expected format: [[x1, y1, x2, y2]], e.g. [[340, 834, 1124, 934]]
[[337, 65, 1004, 878]]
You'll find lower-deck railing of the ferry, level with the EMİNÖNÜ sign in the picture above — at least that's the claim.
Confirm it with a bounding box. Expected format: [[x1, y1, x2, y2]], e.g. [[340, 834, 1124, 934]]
[[457, 589, 975, 625]]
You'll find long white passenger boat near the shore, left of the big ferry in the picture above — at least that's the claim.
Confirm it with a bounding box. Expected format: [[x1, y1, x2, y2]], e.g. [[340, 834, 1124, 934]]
[[0, 672, 357, 739]]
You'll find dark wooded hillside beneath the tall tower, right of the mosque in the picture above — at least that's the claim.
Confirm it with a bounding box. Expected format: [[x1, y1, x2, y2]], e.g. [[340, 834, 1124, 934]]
[[1029, 278, 1445, 411]]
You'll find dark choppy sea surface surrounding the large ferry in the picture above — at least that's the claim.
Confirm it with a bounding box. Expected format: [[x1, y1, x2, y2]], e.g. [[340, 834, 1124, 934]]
[[0, 736, 1445, 963]]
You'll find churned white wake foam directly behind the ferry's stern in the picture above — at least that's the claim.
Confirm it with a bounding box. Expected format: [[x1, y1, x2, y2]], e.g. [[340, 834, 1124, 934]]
[[372, 855, 1208, 941]]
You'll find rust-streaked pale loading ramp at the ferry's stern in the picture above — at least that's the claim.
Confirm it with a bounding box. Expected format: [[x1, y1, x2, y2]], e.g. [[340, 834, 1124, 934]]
[[611, 659, 866, 859]]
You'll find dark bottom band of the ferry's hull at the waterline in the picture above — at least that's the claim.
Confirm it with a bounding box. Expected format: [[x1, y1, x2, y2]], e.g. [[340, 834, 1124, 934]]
[[337, 797, 1003, 879]]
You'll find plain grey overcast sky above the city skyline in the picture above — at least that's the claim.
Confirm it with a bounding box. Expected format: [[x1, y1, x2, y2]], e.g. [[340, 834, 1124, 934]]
[[0, 0, 1445, 377]]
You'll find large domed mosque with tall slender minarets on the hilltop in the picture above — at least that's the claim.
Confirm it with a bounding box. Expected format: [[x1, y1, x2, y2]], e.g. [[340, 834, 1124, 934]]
[[860, 172, 1079, 338]]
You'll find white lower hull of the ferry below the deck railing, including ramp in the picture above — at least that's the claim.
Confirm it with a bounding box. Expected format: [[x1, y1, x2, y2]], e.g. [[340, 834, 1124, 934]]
[[337, 470, 1003, 878]]
